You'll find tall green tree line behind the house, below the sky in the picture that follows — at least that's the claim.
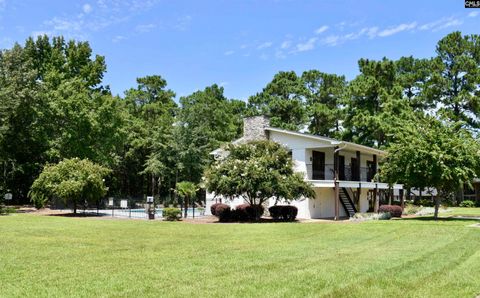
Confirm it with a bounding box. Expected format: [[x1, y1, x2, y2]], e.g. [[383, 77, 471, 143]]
[[0, 32, 480, 206]]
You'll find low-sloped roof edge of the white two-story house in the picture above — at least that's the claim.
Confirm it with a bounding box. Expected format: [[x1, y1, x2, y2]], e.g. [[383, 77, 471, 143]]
[[210, 127, 386, 156]]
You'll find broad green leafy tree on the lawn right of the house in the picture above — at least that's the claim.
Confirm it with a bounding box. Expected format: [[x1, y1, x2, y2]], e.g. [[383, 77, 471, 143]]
[[382, 117, 480, 219]]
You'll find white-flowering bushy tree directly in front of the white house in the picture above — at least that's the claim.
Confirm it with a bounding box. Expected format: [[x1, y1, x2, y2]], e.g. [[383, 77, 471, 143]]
[[206, 141, 314, 210]]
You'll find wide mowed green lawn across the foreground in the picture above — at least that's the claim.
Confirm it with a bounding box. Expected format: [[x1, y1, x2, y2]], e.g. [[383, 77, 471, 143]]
[[0, 214, 480, 297]]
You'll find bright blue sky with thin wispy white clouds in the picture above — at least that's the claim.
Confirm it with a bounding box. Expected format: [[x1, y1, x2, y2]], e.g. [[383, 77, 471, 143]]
[[0, 0, 480, 99]]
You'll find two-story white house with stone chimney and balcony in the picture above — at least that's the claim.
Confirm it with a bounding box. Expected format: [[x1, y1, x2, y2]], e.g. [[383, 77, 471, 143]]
[[206, 116, 403, 219]]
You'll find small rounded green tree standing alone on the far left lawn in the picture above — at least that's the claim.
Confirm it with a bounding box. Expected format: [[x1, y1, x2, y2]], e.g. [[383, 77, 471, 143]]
[[29, 158, 110, 212]]
